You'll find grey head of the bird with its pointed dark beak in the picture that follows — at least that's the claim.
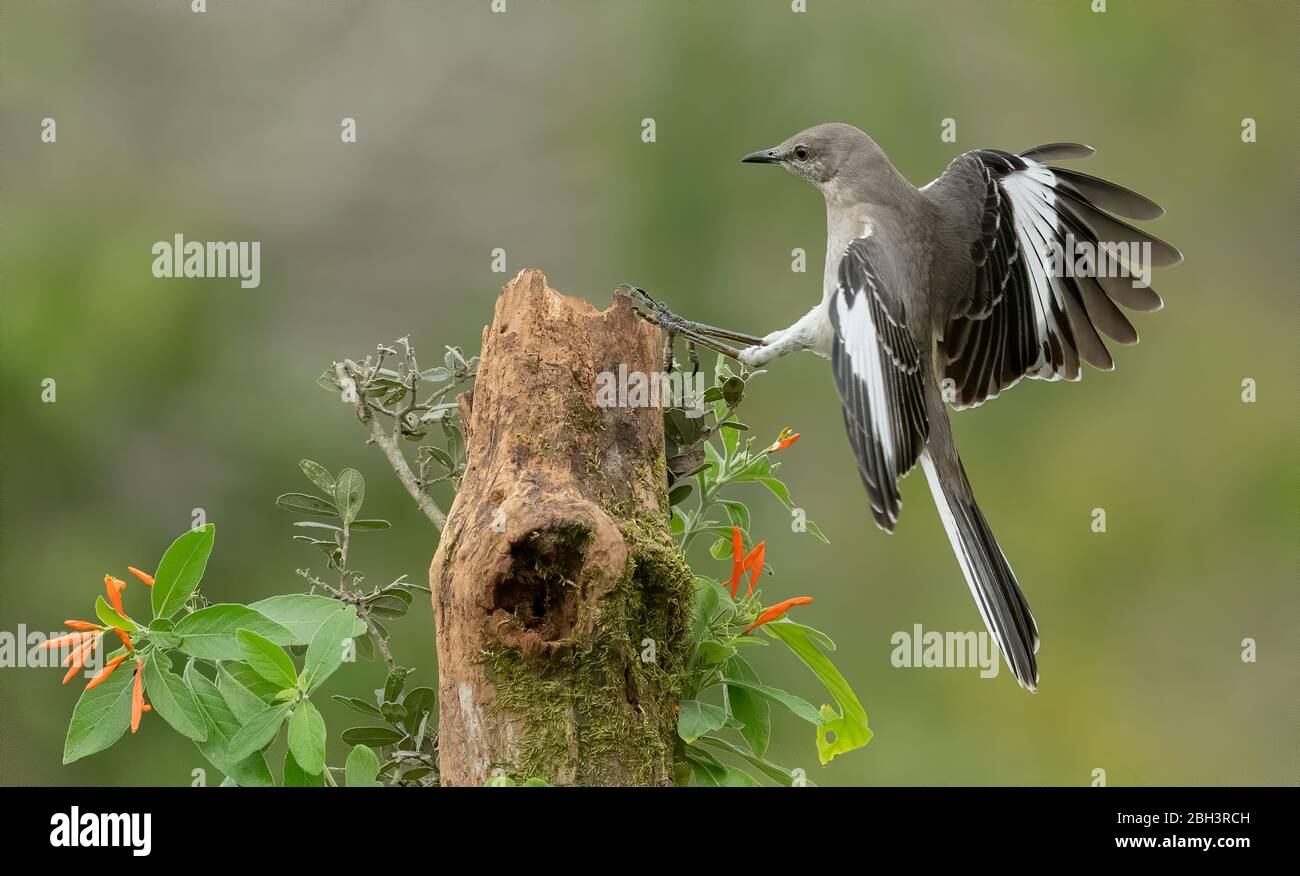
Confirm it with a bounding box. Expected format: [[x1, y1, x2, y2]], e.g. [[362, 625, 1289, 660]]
[[741, 122, 897, 201]]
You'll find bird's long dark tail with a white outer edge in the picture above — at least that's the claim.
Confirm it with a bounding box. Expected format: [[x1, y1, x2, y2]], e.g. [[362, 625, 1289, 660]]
[[920, 439, 1039, 691]]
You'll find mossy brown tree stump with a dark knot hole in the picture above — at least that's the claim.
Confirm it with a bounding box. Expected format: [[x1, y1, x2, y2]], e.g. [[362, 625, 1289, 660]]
[[429, 269, 693, 785]]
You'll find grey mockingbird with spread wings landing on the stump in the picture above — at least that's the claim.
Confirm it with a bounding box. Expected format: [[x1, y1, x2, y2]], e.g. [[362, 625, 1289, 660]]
[[637, 125, 1182, 691]]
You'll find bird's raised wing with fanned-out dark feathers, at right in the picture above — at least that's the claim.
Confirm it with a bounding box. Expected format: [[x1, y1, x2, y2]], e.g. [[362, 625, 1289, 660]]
[[936, 143, 1182, 408]]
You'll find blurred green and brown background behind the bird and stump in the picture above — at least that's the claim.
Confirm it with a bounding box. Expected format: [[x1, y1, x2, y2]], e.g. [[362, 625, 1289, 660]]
[[0, 0, 1300, 785]]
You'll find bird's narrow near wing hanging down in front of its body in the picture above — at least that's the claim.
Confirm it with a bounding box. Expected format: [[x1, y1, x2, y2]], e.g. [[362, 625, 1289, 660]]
[[831, 237, 930, 532]]
